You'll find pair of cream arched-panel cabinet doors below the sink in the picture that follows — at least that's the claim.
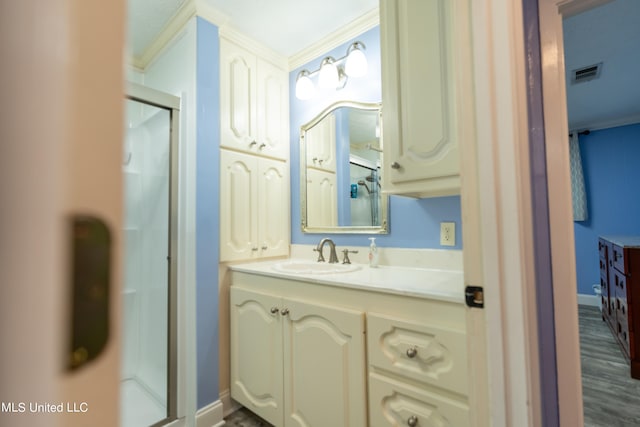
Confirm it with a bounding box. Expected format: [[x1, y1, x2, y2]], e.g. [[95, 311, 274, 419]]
[[231, 286, 367, 427]]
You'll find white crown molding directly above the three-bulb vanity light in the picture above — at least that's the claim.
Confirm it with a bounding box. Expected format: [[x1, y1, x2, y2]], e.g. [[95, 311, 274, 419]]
[[289, 8, 380, 71]]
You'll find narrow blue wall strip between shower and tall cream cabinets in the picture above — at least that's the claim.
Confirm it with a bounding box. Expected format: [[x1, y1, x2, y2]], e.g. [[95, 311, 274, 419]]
[[196, 18, 220, 409]]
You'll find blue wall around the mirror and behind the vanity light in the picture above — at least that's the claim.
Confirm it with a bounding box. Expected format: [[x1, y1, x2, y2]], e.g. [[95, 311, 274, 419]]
[[289, 27, 462, 249]]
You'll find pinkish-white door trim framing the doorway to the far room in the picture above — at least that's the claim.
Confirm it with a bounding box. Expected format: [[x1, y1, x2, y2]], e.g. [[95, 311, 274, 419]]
[[538, 0, 588, 426]]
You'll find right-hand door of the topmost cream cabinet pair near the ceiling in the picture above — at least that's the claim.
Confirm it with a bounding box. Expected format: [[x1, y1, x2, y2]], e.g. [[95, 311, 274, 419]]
[[257, 60, 289, 159]]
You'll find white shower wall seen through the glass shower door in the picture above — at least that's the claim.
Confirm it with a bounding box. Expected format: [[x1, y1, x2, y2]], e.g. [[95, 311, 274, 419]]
[[123, 108, 170, 405]]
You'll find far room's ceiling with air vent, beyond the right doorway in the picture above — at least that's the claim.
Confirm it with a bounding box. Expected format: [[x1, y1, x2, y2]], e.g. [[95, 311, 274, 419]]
[[563, 0, 640, 130]]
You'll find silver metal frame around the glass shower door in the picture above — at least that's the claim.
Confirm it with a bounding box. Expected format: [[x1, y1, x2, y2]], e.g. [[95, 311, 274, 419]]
[[125, 82, 180, 427]]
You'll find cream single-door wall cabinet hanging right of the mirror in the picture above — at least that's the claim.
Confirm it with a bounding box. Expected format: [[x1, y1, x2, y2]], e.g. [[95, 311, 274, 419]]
[[380, 0, 471, 197]]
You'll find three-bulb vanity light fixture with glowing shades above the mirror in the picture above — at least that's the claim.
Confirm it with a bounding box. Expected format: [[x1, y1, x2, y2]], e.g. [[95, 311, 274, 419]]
[[296, 41, 367, 100]]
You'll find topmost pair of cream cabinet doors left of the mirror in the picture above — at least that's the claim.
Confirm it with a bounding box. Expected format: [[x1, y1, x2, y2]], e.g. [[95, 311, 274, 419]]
[[220, 38, 289, 159]]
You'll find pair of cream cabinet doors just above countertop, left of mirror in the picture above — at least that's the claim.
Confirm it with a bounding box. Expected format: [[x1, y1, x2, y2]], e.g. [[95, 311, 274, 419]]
[[220, 149, 290, 262]]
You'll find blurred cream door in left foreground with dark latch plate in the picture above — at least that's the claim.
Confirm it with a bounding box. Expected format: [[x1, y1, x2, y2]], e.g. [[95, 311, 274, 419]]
[[0, 0, 125, 427]]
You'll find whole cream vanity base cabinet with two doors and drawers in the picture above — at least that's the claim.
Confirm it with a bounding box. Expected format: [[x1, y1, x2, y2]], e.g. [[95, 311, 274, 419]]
[[231, 270, 471, 427]]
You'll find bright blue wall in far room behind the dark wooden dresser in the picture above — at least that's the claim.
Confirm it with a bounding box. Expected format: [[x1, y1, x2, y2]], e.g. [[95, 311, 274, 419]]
[[574, 124, 640, 295]]
